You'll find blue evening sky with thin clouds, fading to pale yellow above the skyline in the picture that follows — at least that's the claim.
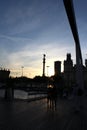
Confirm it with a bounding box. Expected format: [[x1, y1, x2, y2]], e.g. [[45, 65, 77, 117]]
[[0, 0, 87, 78]]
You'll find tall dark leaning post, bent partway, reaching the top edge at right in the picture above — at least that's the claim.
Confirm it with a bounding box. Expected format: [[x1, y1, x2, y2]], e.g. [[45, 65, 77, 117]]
[[63, 0, 84, 90]]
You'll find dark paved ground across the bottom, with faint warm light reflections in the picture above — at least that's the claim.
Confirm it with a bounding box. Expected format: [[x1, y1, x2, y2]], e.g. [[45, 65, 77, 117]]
[[0, 97, 87, 130]]
